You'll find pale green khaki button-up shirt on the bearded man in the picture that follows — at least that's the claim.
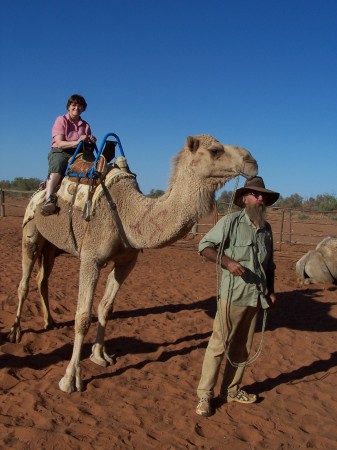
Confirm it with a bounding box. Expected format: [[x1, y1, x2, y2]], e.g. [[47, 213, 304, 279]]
[[199, 209, 275, 308]]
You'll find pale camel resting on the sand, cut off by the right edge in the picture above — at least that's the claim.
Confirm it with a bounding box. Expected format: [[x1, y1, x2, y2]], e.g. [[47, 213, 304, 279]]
[[296, 236, 337, 285]]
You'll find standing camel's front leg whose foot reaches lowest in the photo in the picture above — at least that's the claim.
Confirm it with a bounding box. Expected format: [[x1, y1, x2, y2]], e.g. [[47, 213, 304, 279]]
[[59, 259, 100, 394]]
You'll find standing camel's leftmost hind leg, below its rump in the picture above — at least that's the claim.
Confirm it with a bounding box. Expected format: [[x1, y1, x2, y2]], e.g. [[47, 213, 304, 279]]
[[8, 220, 45, 342]]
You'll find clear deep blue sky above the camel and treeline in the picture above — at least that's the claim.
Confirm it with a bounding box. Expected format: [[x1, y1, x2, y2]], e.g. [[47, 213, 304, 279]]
[[0, 0, 337, 199]]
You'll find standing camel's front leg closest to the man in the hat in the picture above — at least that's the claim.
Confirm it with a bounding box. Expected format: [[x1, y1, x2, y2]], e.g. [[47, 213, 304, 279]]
[[90, 255, 137, 367]]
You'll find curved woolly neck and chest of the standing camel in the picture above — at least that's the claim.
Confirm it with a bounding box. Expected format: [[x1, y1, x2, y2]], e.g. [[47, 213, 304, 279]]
[[113, 170, 214, 248]]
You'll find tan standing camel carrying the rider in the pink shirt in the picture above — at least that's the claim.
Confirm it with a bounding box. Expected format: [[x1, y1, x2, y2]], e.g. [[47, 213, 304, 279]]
[[9, 134, 258, 393]]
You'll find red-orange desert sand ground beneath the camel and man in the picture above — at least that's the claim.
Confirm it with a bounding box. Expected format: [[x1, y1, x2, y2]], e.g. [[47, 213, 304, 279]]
[[0, 201, 337, 450]]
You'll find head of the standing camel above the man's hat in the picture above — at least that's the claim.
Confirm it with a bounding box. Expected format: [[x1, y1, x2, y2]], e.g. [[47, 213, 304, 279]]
[[184, 134, 258, 186]]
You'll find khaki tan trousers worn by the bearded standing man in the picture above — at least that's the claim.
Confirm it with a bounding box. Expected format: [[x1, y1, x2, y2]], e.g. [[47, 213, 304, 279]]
[[197, 300, 259, 398]]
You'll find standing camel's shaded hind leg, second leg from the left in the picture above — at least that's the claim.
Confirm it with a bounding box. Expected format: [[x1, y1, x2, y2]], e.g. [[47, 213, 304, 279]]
[[36, 242, 56, 330]]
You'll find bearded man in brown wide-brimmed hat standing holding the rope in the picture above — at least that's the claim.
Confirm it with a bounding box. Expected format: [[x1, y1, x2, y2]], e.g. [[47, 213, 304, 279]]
[[196, 177, 280, 417]]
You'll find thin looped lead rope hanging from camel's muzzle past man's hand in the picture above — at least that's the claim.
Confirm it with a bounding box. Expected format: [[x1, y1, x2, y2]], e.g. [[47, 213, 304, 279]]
[[216, 176, 267, 367]]
